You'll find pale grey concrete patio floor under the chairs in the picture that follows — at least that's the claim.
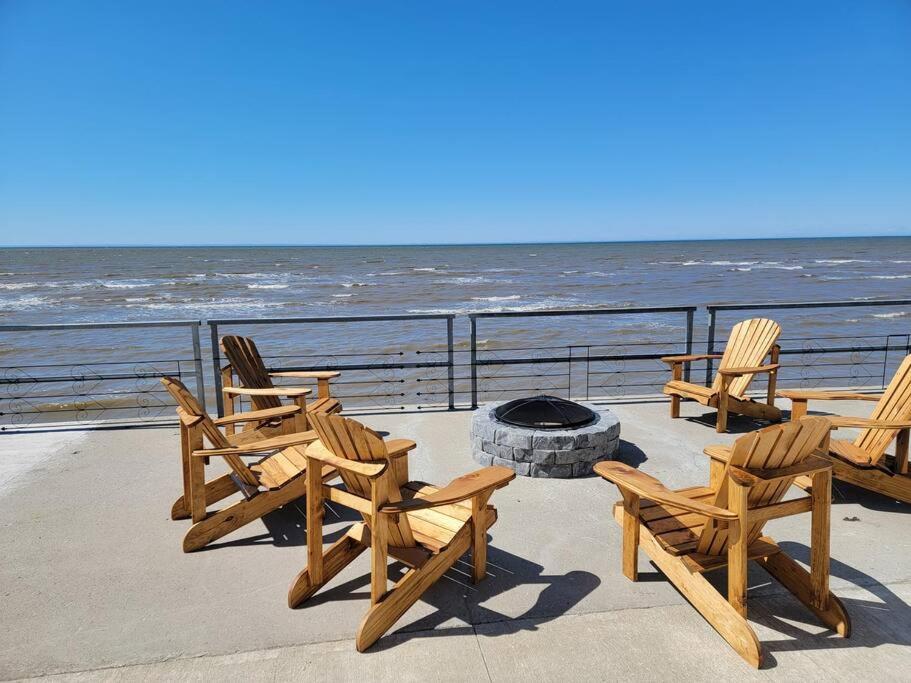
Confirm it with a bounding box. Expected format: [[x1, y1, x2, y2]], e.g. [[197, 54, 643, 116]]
[[0, 400, 911, 681]]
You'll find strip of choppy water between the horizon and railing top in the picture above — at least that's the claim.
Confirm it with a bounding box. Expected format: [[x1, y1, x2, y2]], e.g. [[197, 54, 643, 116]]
[[0, 238, 911, 324]]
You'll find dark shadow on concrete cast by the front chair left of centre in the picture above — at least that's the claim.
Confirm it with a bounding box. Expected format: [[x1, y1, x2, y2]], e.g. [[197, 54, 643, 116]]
[[297, 545, 601, 652]]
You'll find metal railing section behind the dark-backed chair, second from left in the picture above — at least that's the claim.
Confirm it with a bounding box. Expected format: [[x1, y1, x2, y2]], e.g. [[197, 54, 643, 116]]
[[208, 314, 455, 415]]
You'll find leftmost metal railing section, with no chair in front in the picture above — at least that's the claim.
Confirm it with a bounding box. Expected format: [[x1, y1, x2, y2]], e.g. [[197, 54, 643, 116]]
[[0, 320, 205, 430]]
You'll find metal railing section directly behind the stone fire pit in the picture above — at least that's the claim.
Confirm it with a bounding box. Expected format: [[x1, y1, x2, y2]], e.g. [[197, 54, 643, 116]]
[[468, 306, 696, 408]]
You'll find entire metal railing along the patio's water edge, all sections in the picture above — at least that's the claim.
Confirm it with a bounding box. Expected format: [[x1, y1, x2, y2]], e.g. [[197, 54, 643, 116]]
[[0, 299, 911, 430]]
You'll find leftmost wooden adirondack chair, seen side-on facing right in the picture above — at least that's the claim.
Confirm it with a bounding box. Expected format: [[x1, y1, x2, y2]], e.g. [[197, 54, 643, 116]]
[[161, 377, 337, 553]]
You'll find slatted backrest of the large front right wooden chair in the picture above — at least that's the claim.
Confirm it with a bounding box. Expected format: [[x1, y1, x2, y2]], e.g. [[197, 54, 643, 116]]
[[697, 417, 829, 555]]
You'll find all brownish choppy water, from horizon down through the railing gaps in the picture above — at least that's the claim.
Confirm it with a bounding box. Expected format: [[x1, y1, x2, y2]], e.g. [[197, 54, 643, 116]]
[[0, 238, 911, 420]]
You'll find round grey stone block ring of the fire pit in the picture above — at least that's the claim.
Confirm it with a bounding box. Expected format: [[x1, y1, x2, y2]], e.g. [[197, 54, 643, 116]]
[[471, 397, 620, 478]]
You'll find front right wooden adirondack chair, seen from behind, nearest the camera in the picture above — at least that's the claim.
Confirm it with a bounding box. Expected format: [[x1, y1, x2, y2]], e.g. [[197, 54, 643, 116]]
[[595, 417, 850, 668]]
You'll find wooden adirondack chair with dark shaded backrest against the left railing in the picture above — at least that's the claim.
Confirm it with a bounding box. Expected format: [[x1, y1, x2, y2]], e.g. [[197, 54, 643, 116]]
[[221, 335, 342, 431]]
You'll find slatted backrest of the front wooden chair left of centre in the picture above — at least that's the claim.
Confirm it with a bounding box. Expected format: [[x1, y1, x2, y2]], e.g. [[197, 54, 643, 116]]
[[310, 413, 415, 548]]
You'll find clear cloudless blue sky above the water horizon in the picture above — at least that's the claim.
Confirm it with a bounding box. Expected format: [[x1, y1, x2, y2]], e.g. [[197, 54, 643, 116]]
[[0, 0, 911, 245]]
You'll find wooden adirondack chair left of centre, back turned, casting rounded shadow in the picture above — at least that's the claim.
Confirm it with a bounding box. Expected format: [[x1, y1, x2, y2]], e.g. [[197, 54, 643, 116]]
[[288, 413, 516, 652]]
